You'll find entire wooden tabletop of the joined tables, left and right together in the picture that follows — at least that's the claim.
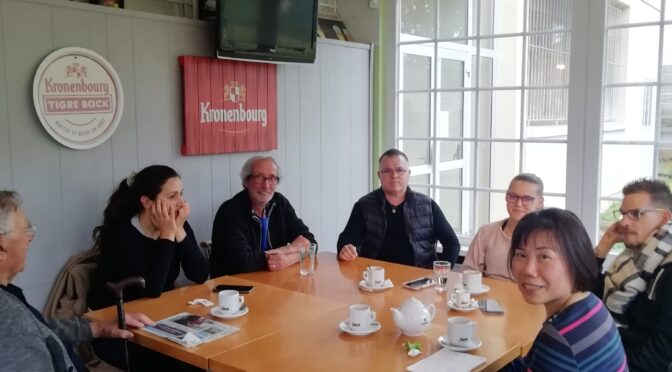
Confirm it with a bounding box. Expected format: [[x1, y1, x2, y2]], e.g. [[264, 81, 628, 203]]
[[89, 252, 544, 371]]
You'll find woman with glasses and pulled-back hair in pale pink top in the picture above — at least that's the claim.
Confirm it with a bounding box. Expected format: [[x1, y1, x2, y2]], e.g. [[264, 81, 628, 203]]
[[462, 173, 544, 280]]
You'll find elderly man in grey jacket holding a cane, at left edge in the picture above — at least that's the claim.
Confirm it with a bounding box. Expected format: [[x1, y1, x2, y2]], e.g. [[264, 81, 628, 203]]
[[0, 191, 152, 371]]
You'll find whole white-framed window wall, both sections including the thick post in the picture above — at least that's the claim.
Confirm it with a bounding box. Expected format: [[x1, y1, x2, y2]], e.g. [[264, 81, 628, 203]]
[[395, 0, 672, 240]]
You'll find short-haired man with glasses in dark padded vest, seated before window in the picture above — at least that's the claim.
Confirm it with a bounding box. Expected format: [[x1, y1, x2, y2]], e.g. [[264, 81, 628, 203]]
[[337, 149, 460, 268]]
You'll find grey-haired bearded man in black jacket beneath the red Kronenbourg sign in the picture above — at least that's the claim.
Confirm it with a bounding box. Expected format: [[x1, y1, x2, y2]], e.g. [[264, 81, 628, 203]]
[[210, 156, 316, 278]]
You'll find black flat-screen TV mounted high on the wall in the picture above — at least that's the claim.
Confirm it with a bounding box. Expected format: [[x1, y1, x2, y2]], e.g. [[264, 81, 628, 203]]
[[217, 0, 318, 63]]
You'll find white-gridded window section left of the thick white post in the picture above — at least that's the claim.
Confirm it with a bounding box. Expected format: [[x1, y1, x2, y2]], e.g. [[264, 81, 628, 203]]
[[397, 0, 572, 236]]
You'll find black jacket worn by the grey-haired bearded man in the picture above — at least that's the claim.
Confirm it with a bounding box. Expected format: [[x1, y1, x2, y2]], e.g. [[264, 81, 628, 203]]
[[210, 190, 316, 278]]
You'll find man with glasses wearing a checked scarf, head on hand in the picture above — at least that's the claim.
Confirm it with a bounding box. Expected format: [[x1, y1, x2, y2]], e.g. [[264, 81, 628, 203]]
[[593, 179, 672, 371]]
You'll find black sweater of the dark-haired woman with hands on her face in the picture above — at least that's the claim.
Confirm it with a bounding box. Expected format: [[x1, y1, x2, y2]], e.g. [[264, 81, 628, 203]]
[[87, 221, 209, 310]]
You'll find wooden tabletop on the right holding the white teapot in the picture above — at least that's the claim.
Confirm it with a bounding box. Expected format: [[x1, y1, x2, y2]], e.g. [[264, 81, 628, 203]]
[[228, 252, 545, 371]]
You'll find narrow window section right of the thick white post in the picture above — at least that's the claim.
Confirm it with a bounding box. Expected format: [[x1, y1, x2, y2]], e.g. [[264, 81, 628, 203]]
[[600, 1, 672, 238]]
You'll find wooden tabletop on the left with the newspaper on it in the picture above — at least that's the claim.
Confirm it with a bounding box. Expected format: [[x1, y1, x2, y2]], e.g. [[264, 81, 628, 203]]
[[87, 276, 345, 369]]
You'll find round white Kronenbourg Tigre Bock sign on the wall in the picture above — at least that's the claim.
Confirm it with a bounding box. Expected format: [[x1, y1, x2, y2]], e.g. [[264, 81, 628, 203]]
[[33, 48, 124, 149]]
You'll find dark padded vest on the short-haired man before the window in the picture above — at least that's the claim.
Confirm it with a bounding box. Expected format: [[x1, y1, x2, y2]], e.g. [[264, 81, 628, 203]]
[[359, 188, 436, 268]]
